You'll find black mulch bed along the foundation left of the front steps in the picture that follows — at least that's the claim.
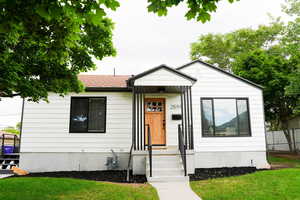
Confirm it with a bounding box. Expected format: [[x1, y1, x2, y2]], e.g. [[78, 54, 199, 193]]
[[10, 170, 147, 183]]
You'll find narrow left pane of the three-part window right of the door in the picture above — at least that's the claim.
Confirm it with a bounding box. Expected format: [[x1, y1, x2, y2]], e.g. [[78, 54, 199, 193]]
[[202, 100, 214, 136]]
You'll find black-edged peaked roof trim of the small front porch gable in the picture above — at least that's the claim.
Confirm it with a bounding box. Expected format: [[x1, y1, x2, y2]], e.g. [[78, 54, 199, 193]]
[[128, 64, 197, 86]]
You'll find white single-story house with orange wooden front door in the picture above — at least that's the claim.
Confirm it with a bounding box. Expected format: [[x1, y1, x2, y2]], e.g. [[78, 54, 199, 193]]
[[20, 60, 269, 181]]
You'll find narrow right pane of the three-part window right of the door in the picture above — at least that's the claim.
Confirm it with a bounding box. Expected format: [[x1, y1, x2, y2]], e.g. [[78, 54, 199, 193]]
[[237, 100, 250, 135]]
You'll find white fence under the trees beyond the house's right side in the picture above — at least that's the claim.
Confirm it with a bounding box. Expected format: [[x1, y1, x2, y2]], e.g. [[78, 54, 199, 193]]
[[267, 129, 300, 152]]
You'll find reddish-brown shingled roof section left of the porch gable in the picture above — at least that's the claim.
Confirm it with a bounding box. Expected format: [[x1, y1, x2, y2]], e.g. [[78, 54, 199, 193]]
[[78, 75, 130, 88]]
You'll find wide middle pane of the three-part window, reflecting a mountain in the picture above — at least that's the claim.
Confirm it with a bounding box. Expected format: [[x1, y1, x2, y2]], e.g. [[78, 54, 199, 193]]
[[214, 99, 238, 136]]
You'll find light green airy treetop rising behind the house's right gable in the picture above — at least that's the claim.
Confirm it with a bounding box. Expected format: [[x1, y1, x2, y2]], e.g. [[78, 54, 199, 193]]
[[191, 20, 284, 69]]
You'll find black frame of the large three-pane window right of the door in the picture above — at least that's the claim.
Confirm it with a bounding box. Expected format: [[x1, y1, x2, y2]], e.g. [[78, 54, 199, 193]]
[[200, 97, 252, 138]]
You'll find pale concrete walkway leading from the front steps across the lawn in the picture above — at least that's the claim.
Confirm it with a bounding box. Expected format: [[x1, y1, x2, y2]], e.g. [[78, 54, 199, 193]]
[[150, 181, 201, 200]]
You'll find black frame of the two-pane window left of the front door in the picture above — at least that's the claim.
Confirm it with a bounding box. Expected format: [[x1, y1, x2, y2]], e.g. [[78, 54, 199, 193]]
[[69, 96, 107, 134]]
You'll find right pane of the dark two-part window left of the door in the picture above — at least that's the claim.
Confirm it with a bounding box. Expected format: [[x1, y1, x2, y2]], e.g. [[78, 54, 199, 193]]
[[89, 98, 105, 132]]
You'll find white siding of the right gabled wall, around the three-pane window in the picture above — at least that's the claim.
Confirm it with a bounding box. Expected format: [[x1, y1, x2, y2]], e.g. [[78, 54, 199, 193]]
[[181, 63, 266, 152]]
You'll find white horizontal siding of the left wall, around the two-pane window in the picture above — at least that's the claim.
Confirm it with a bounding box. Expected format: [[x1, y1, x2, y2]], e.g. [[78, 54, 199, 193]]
[[21, 92, 132, 152]]
